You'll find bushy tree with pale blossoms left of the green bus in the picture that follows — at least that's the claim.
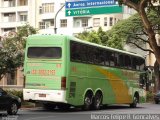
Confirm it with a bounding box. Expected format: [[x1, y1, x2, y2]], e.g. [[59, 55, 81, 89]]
[[0, 24, 36, 80]]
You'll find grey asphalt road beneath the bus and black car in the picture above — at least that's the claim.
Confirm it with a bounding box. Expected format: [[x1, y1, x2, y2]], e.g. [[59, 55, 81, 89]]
[[0, 103, 160, 120]]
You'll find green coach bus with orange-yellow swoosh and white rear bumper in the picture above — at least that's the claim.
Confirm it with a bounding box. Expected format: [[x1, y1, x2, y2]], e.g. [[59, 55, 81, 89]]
[[23, 34, 146, 109]]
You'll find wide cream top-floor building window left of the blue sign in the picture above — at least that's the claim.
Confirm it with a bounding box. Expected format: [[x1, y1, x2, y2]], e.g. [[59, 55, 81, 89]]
[[42, 3, 54, 13]]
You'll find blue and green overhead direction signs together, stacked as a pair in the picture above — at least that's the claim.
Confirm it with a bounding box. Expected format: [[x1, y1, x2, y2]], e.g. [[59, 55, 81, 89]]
[[65, 0, 122, 16]]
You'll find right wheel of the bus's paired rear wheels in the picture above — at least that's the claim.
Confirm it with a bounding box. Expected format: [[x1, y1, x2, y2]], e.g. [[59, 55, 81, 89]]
[[93, 91, 103, 110]]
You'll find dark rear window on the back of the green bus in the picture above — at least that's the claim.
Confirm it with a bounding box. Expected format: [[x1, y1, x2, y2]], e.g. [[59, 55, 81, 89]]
[[27, 47, 62, 59]]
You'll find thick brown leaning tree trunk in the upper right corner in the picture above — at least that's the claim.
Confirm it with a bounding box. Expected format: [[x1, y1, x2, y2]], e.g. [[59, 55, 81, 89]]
[[118, 0, 160, 64]]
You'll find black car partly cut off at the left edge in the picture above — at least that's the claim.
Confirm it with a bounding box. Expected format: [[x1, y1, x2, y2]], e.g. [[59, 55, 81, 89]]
[[0, 88, 21, 115]]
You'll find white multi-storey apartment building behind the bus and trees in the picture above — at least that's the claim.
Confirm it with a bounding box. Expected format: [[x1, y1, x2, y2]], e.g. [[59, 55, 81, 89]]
[[0, 0, 139, 88]]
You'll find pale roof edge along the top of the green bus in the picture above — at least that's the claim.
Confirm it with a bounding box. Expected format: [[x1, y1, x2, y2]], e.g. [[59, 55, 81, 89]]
[[29, 34, 144, 59]]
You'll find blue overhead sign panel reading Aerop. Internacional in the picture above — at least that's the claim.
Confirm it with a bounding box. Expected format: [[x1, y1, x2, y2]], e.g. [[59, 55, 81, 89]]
[[65, 0, 116, 9]]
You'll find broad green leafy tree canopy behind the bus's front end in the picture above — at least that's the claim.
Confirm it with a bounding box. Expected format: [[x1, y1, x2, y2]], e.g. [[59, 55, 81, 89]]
[[107, 11, 160, 53]]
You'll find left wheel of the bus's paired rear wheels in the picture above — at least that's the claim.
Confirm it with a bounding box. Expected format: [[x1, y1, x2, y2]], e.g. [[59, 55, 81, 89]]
[[82, 92, 93, 110]]
